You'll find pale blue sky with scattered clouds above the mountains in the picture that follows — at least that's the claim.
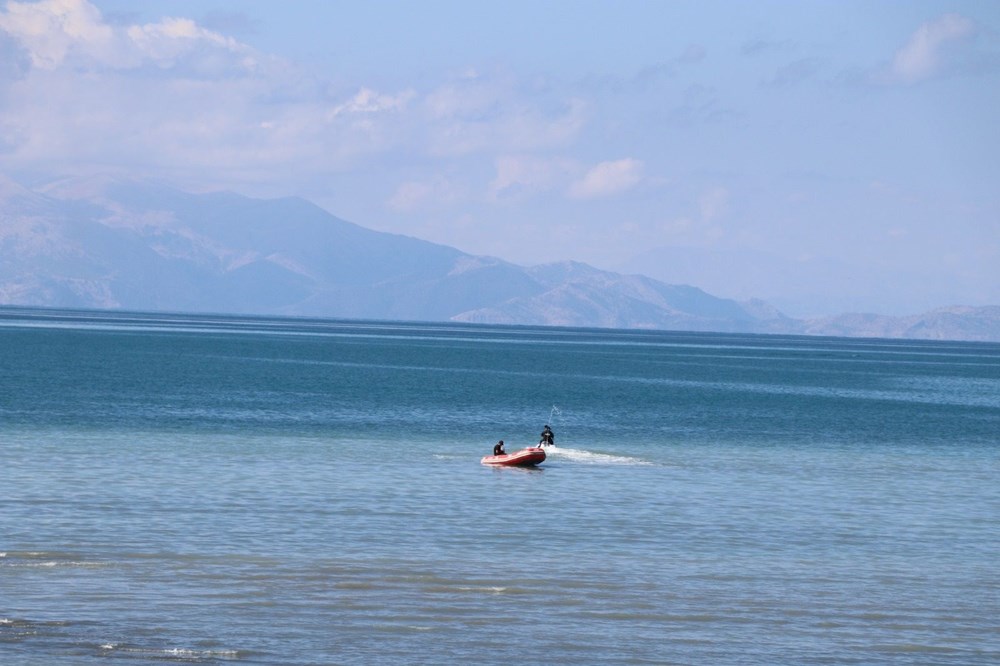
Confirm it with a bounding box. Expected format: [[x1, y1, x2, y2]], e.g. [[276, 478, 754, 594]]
[[0, 0, 1000, 316]]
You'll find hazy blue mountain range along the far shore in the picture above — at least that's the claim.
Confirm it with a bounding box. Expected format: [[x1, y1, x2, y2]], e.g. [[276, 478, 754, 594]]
[[0, 177, 1000, 341]]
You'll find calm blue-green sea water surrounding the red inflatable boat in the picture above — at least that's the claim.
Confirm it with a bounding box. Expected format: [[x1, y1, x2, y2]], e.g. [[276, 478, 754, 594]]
[[0, 309, 1000, 665]]
